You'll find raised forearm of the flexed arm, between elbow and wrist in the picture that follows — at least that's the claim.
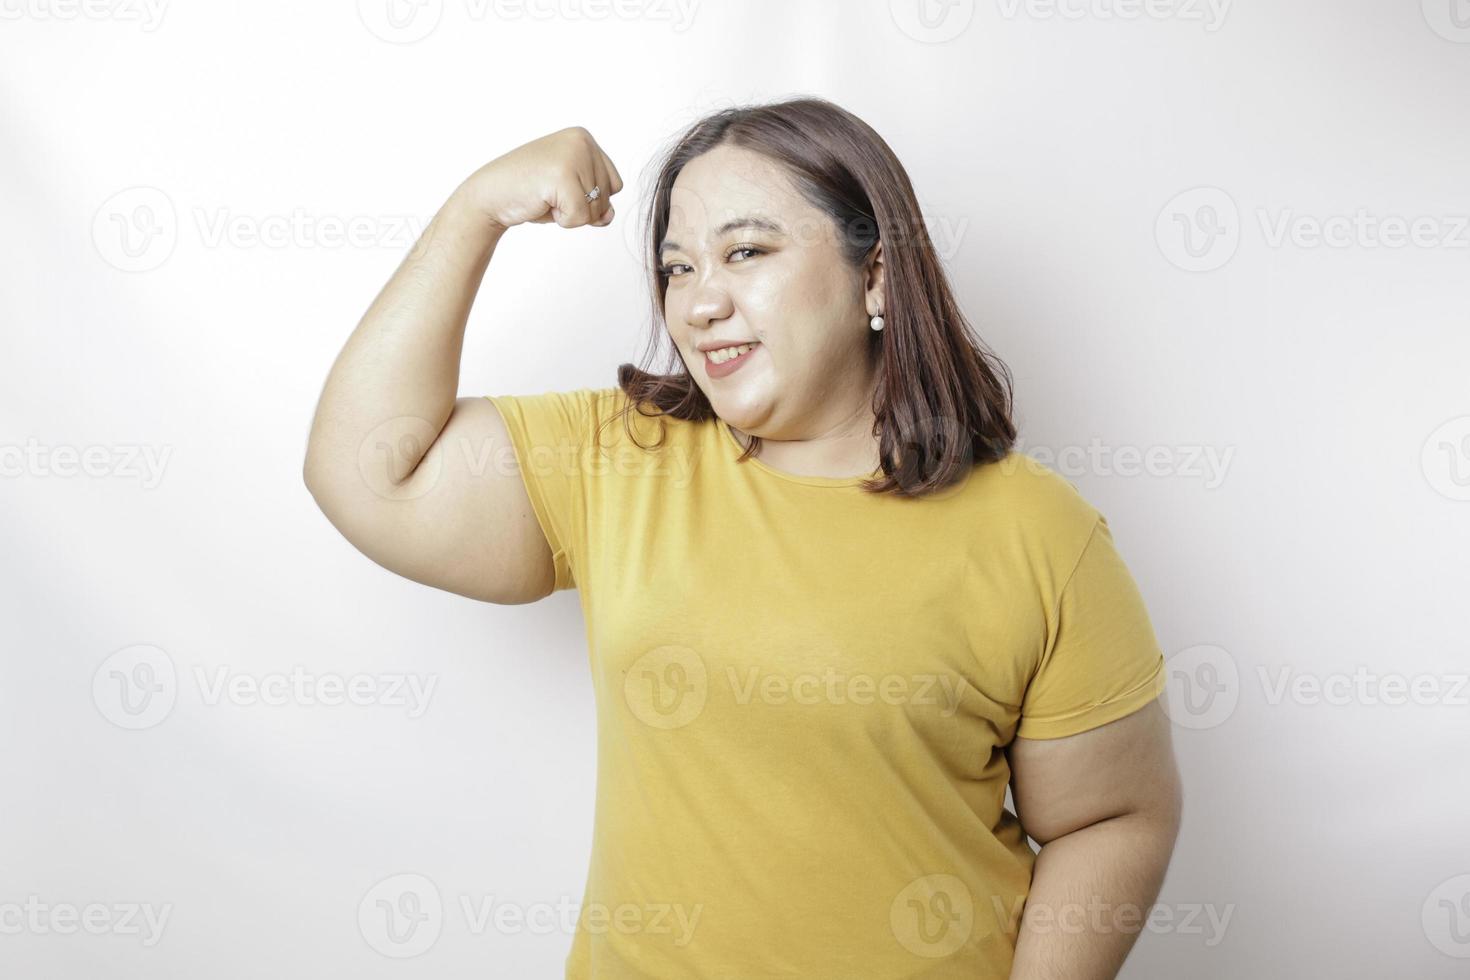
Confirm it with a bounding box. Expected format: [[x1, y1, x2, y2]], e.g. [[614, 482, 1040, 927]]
[[306, 182, 506, 483]]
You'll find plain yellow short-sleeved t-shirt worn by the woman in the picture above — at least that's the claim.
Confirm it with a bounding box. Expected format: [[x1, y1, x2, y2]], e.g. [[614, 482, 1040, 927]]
[[488, 388, 1166, 980]]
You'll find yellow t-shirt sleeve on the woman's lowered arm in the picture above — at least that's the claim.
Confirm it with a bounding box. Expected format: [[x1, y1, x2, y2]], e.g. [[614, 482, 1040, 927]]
[[1016, 514, 1167, 739]]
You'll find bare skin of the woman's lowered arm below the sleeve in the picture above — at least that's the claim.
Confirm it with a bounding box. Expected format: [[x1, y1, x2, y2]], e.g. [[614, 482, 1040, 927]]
[[1007, 696, 1183, 980]]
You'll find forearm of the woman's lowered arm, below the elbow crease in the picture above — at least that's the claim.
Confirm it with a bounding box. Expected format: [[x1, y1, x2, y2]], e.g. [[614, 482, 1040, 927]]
[[1010, 813, 1179, 980]]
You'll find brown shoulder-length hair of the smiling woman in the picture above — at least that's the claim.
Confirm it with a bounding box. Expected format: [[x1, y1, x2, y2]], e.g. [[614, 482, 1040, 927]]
[[602, 97, 1016, 497]]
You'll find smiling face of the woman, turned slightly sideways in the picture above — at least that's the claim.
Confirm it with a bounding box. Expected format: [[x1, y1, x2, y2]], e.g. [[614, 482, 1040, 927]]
[[660, 145, 882, 439]]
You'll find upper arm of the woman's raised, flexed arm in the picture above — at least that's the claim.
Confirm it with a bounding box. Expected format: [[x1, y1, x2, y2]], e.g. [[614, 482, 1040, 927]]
[[301, 397, 554, 604]]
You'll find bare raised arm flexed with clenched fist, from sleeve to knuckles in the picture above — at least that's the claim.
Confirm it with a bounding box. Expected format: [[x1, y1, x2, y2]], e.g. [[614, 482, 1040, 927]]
[[303, 126, 622, 604]]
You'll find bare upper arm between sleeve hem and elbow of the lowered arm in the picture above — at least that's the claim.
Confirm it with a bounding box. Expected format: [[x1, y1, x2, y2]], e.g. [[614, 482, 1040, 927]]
[[1005, 695, 1183, 845]]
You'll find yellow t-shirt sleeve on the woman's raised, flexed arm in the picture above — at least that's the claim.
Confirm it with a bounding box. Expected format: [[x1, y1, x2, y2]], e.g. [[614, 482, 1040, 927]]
[[485, 388, 601, 592]]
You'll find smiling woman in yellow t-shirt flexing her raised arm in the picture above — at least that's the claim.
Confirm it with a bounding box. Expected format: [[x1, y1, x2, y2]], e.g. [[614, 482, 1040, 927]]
[[306, 98, 1180, 980]]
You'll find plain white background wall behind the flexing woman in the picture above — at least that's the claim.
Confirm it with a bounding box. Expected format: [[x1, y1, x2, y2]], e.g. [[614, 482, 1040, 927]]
[[0, 0, 1470, 980]]
